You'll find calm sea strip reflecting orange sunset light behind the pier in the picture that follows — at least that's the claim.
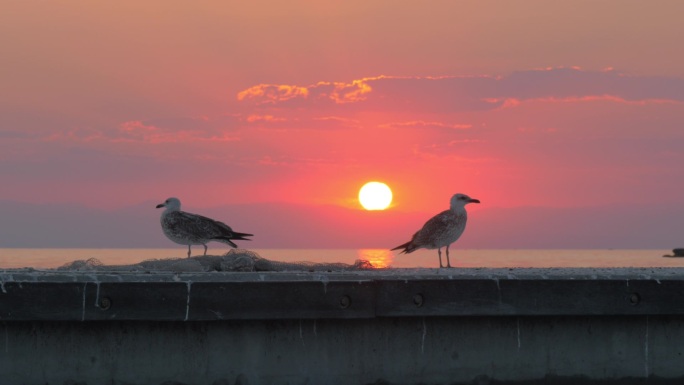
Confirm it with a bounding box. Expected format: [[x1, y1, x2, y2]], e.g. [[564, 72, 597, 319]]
[[0, 246, 684, 269]]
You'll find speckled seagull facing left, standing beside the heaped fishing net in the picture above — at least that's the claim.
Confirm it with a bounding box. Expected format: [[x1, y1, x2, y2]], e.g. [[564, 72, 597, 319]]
[[157, 198, 253, 258]]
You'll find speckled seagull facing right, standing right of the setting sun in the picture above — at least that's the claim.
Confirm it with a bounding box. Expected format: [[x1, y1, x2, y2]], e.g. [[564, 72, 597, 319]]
[[392, 194, 480, 268]]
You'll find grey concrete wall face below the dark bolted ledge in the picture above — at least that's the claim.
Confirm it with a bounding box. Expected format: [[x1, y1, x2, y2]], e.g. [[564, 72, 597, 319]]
[[0, 316, 684, 385]]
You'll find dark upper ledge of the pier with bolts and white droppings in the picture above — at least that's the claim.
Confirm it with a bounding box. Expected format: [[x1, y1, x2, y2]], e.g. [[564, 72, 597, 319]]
[[0, 268, 684, 321]]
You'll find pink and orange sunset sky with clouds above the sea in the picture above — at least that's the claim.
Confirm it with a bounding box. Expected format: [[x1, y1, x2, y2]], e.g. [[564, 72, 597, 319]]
[[0, 0, 684, 248]]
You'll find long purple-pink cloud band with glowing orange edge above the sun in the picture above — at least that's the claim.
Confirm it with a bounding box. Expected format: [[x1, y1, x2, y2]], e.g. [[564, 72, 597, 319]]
[[238, 67, 684, 113]]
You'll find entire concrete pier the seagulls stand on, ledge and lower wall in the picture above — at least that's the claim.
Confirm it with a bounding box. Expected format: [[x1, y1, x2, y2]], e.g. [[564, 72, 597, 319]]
[[0, 268, 684, 385]]
